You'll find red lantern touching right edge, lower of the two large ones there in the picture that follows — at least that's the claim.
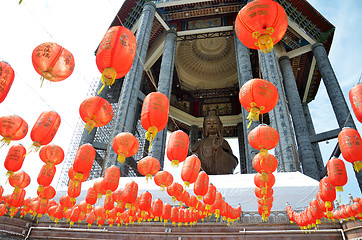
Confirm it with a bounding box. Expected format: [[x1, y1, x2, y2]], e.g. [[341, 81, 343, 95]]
[[338, 127, 362, 172]]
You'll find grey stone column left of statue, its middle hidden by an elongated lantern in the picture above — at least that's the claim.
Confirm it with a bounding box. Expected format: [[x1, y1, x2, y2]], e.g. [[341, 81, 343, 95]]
[[149, 30, 177, 169]]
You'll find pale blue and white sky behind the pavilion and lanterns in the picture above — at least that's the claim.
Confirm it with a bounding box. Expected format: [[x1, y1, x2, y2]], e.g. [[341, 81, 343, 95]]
[[0, 0, 362, 206]]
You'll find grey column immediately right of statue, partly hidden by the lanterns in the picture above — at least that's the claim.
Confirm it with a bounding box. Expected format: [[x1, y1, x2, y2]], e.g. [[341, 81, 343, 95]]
[[234, 34, 259, 173]]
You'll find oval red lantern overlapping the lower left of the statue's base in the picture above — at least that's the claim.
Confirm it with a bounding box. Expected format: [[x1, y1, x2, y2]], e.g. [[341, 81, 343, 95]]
[[181, 155, 201, 187]]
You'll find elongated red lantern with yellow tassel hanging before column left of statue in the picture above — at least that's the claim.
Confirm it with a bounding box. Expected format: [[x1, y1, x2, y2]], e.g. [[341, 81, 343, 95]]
[[141, 92, 170, 147]]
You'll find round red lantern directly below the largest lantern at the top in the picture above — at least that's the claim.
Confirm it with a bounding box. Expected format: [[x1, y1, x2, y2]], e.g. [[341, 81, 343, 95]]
[[239, 78, 279, 128]]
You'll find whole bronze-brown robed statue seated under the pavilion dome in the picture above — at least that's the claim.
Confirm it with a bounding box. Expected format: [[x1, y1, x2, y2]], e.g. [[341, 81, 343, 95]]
[[191, 109, 238, 175]]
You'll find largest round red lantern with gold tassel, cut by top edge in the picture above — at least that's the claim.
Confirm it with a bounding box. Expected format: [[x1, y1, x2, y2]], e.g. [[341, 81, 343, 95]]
[[235, 0, 288, 53]]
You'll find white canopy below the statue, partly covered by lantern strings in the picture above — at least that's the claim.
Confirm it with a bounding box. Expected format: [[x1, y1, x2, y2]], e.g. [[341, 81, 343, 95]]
[[55, 172, 319, 211]]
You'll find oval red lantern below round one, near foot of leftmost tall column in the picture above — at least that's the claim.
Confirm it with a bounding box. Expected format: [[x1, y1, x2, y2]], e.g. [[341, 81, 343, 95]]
[[73, 144, 96, 176]]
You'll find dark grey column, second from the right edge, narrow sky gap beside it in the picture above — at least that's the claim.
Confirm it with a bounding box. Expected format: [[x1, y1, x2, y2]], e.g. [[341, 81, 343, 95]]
[[279, 56, 320, 181]]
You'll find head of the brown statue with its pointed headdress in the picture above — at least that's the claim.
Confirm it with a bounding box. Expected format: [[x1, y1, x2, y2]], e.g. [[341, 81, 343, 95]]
[[202, 109, 223, 138]]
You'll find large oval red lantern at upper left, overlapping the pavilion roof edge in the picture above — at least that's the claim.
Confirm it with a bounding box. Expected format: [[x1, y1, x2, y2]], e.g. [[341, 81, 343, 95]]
[[96, 26, 137, 92]]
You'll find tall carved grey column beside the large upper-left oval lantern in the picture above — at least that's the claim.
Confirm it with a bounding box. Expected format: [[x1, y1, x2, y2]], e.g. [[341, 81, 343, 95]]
[[103, 2, 156, 172]]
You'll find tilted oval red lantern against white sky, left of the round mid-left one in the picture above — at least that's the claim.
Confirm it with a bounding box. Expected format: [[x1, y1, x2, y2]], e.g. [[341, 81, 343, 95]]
[[30, 111, 60, 151]]
